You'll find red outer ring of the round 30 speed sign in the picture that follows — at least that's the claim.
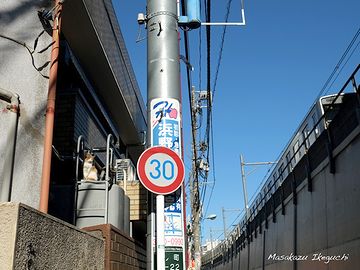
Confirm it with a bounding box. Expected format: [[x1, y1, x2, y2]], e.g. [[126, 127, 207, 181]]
[[136, 146, 185, 195]]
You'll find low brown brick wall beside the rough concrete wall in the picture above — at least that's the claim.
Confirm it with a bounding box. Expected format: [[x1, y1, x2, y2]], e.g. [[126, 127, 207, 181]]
[[83, 224, 146, 270]]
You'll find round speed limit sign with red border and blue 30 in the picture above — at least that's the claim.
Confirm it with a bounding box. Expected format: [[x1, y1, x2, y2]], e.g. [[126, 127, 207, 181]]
[[137, 146, 184, 195]]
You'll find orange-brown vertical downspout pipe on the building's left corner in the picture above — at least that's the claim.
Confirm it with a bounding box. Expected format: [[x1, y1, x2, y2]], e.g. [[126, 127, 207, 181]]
[[39, 0, 62, 213]]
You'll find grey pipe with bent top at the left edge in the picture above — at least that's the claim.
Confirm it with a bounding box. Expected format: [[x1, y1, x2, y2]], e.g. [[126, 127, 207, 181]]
[[0, 88, 20, 202]]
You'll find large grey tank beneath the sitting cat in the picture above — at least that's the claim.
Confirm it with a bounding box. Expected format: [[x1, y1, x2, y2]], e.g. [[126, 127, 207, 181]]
[[76, 182, 130, 235]]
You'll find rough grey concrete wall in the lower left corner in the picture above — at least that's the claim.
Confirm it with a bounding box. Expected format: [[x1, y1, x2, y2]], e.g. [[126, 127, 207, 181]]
[[0, 203, 105, 270]]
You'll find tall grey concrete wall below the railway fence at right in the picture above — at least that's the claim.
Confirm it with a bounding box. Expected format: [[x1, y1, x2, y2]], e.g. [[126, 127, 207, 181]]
[[205, 129, 360, 270]]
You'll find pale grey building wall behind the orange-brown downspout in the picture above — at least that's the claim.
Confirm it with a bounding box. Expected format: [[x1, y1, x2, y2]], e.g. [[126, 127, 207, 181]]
[[0, 0, 52, 208]]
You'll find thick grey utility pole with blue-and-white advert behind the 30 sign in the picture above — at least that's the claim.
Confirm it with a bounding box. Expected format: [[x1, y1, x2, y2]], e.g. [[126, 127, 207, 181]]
[[146, 0, 184, 270]]
